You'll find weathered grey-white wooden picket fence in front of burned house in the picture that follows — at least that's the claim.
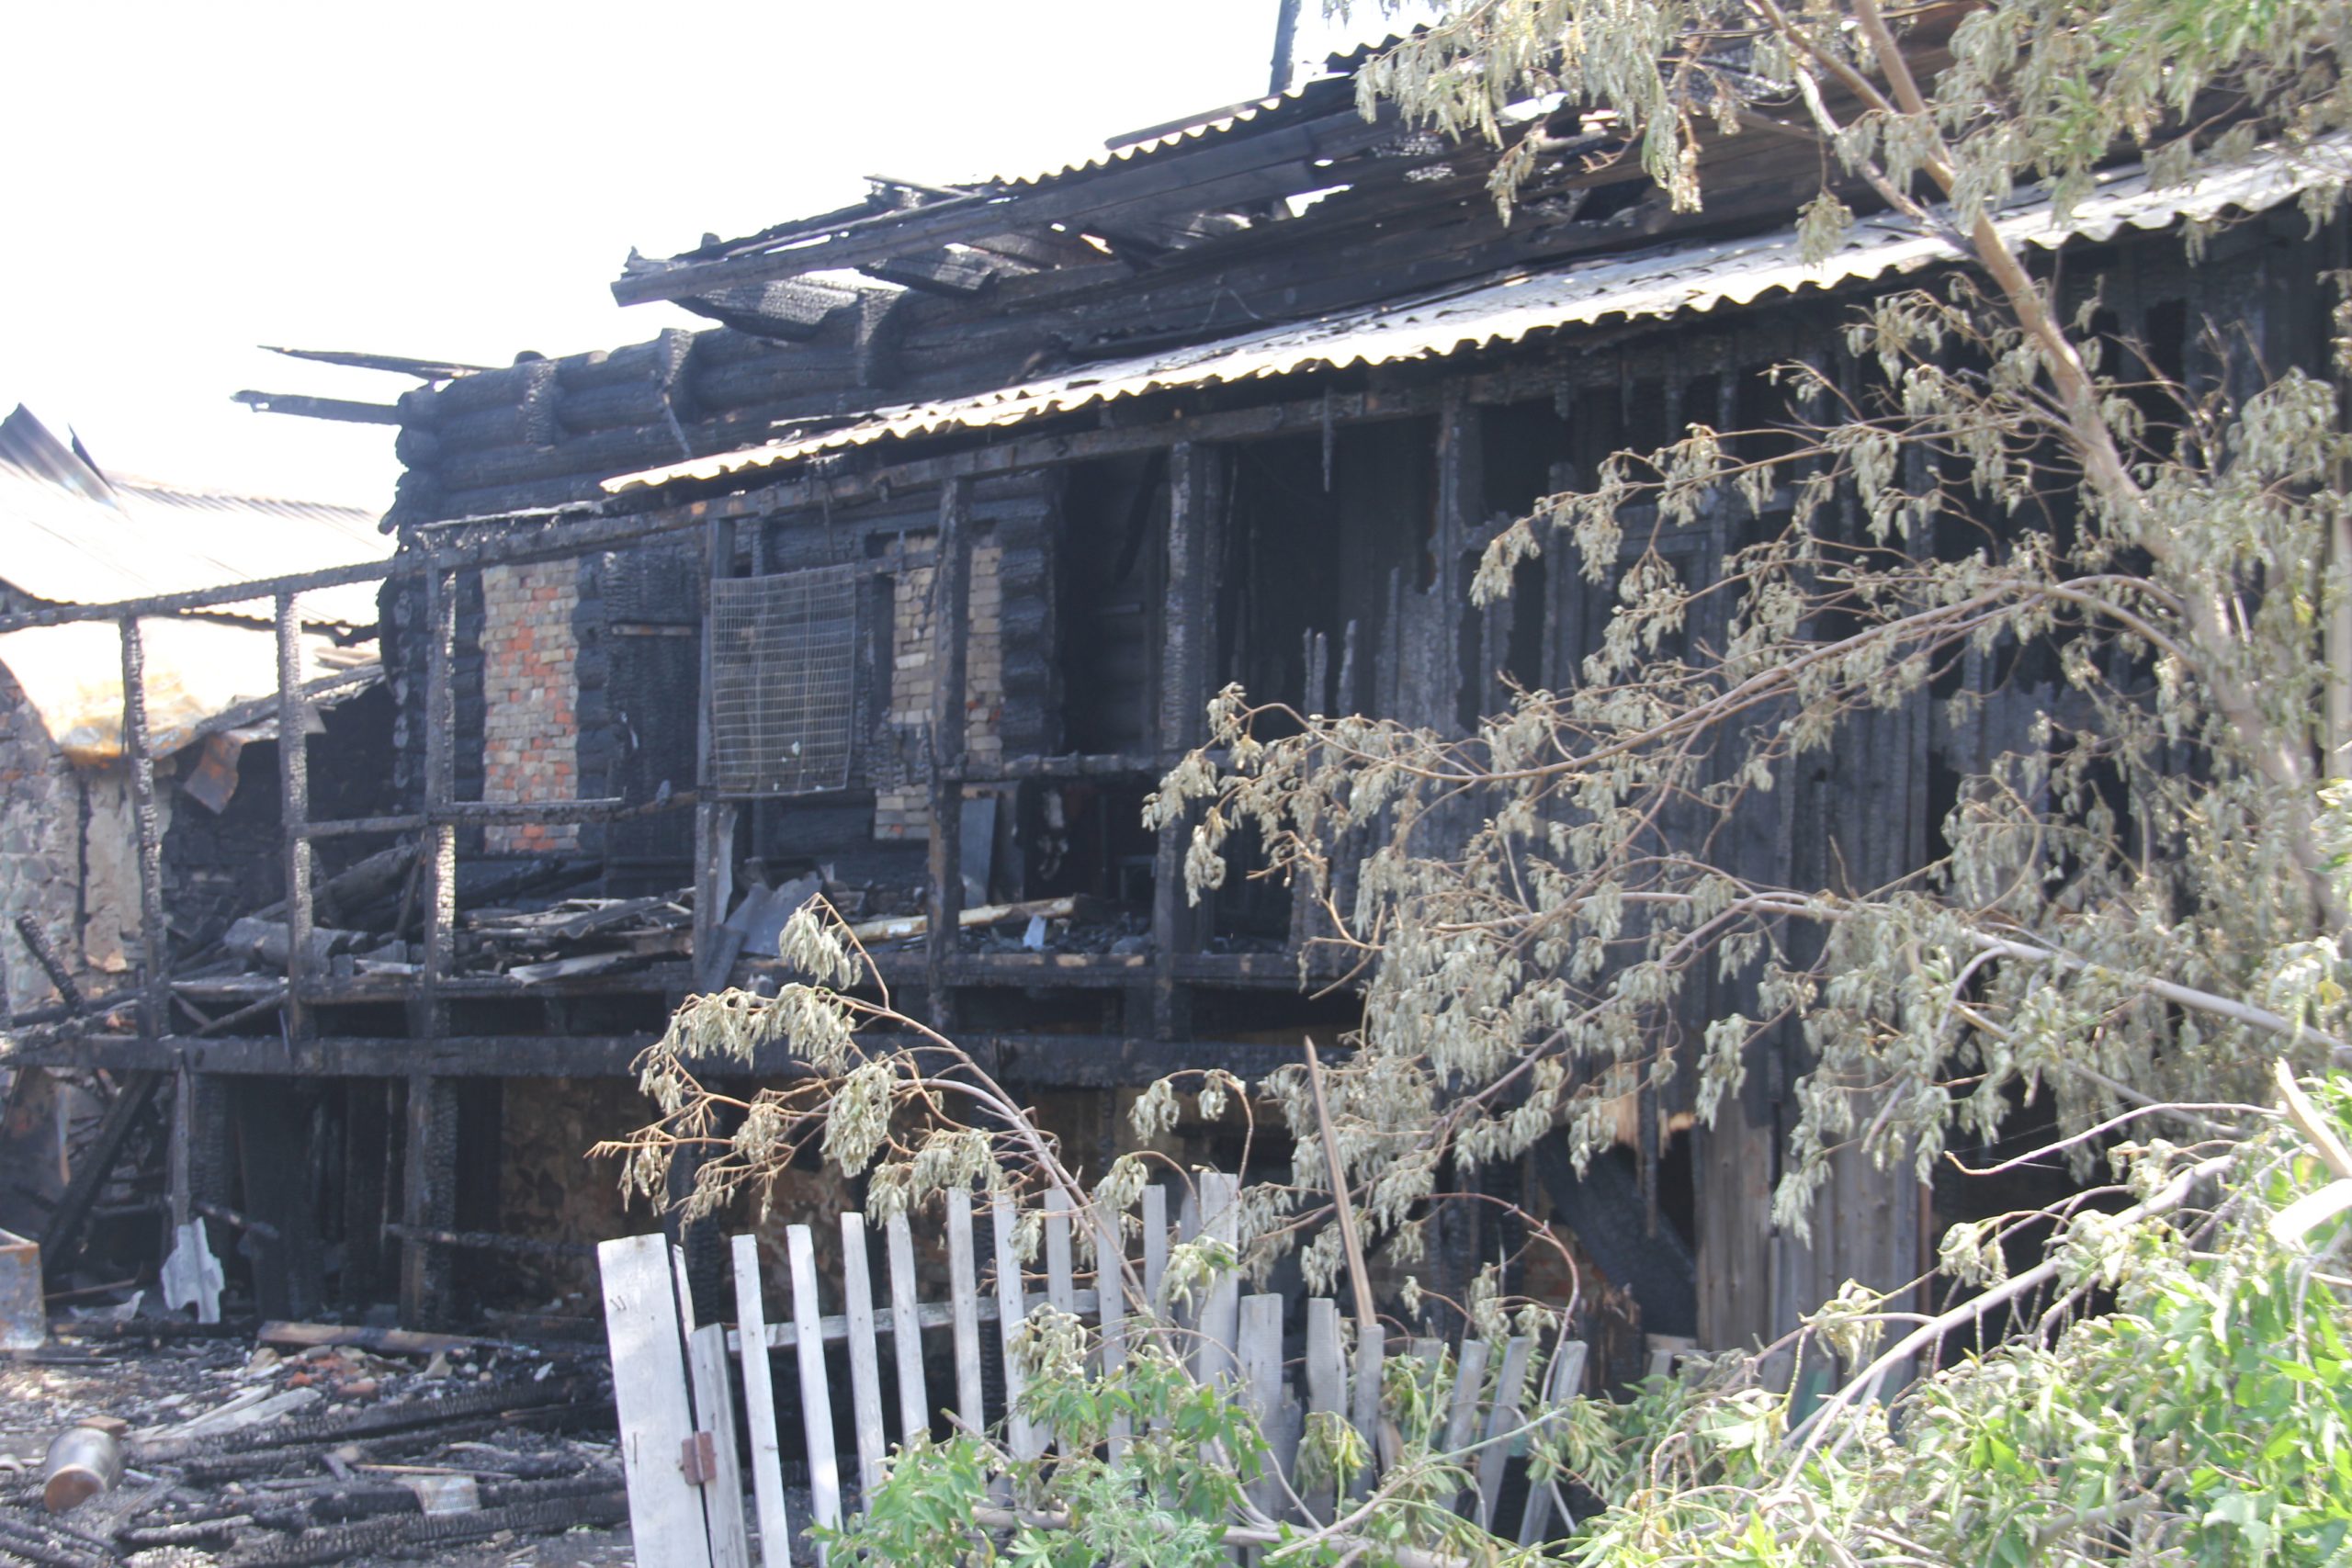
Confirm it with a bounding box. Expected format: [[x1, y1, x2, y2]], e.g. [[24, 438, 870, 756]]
[[597, 1173, 1585, 1568]]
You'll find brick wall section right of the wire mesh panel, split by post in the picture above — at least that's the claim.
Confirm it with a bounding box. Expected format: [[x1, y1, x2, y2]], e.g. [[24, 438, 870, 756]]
[[875, 538, 1004, 840]]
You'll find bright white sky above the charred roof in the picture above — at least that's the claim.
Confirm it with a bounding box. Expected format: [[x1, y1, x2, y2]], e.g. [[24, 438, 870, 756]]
[[0, 0, 1378, 508]]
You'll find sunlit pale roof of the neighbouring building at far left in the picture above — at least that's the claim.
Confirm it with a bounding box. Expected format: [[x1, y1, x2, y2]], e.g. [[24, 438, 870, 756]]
[[0, 409, 395, 626]]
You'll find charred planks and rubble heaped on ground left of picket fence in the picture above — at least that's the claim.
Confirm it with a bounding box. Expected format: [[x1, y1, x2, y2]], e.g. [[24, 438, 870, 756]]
[[0, 1324, 628, 1568]]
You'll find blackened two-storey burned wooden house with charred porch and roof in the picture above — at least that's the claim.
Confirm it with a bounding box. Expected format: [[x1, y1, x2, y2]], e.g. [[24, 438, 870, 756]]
[[0, 42, 2326, 1345]]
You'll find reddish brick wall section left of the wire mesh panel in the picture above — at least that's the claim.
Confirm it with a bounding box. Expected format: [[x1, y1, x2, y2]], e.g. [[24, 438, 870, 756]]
[[482, 559, 579, 853]]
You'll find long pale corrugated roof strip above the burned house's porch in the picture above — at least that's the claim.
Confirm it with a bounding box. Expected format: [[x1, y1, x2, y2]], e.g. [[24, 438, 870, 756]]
[[605, 139, 2352, 491]]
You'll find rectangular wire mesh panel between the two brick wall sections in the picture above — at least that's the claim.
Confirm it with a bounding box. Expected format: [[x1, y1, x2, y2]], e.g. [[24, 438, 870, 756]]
[[710, 567, 861, 795]]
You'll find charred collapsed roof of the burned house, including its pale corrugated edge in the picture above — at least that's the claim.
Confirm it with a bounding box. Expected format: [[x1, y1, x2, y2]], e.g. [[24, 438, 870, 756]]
[[388, 33, 2345, 526]]
